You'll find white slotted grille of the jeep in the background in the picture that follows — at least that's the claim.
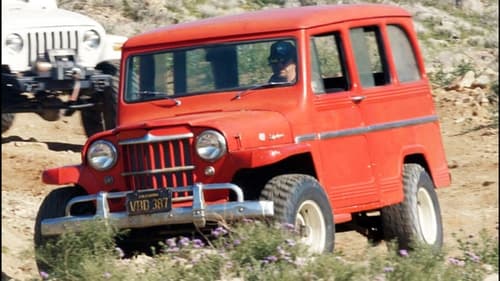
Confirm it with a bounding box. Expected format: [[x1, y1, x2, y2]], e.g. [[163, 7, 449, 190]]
[[27, 30, 79, 66]]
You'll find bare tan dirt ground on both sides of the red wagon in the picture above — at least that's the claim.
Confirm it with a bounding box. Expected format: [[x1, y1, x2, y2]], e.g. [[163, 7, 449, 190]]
[[2, 88, 498, 280]]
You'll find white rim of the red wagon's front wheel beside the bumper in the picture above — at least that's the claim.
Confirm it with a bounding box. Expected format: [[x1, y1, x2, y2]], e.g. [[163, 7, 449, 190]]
[[295, 200, 326, 253]]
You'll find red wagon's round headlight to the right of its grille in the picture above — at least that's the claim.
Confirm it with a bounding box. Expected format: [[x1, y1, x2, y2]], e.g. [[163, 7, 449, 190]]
[[196, 130, 226, 161]]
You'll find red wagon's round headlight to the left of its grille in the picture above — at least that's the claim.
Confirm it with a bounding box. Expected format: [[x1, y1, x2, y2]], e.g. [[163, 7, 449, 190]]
[[87, 140, 118, 171]]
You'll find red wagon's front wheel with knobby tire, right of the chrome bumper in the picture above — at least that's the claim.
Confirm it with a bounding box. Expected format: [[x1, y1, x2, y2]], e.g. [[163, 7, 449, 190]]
[[260, 174, 335, 253]]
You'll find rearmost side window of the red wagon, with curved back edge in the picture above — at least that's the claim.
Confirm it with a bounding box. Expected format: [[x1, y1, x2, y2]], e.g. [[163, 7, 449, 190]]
[[387, 25, 420, 82]]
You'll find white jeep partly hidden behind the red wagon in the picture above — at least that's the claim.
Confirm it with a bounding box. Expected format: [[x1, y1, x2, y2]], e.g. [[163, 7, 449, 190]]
[[1, 0, 127, 136]]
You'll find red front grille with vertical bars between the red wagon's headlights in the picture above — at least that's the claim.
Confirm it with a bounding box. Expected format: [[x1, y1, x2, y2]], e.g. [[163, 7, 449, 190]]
[[120, 133, 194, 191]]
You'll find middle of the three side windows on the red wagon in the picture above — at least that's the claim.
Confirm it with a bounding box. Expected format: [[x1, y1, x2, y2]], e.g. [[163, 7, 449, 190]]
[[350, 26, 390, 87]]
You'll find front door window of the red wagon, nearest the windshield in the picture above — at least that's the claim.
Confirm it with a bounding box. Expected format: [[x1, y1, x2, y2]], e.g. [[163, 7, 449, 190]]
[[311, 32, 350, 93]]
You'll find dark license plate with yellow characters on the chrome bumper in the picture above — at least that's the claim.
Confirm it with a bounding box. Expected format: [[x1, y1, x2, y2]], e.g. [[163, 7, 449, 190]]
[[126, 188, 172, 216]]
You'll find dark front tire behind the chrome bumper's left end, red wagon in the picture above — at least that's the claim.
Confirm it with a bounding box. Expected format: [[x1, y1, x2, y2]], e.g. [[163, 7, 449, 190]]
[[34, 186, 95, 272]]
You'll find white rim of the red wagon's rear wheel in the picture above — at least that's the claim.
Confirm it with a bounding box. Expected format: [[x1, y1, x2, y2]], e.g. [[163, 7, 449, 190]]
[[417, 187, 438, 245]]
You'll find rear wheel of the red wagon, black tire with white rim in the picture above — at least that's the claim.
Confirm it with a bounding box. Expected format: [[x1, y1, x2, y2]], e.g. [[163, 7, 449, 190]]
[[381, 164, 443, 250]]
